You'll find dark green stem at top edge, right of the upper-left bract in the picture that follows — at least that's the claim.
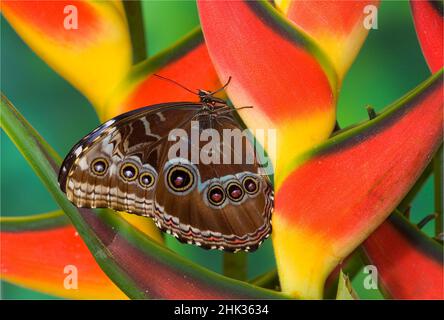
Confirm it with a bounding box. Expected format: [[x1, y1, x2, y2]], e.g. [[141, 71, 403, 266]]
[[123, 0, 148, 64]]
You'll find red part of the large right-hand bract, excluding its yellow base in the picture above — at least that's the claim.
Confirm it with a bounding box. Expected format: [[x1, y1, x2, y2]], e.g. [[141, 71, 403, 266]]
[[276, 80, 443, 240]]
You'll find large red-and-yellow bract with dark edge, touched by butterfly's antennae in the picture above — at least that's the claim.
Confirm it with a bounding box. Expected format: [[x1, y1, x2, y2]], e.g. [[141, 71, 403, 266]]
[[198, 1, 337, 181]]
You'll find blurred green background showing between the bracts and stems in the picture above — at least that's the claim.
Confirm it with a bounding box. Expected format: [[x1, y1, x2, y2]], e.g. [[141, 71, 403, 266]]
[[0, 0, 433, 299]]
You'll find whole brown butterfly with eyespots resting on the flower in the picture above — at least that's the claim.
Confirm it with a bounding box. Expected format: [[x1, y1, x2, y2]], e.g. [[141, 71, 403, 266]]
[[58, 76, 274, 252]]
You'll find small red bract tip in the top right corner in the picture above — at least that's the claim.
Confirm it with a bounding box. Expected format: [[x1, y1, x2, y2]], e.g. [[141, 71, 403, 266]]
[[410, 0, 444, 72]]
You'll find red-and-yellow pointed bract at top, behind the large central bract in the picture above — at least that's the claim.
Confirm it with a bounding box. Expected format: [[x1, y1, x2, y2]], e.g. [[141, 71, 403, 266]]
[[276, 0, 379, 79]]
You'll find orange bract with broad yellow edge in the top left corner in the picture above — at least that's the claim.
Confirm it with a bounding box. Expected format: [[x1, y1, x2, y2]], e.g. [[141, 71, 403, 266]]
[[2, 0, 131, 109]]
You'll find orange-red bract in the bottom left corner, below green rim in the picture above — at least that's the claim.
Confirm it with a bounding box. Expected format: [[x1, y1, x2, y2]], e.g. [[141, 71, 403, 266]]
[[1, 225, 126, 299]]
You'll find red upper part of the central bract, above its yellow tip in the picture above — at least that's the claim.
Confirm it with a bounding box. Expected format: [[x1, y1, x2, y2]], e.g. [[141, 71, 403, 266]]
[[198, 1, 334, 122]]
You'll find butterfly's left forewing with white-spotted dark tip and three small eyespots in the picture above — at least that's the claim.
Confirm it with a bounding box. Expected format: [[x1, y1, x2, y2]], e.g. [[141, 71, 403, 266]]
[[59, 103, 201, 216]]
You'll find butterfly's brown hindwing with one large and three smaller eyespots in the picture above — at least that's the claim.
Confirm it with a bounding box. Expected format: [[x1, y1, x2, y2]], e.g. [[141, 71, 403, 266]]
[[154, 114, 273, 251]]
